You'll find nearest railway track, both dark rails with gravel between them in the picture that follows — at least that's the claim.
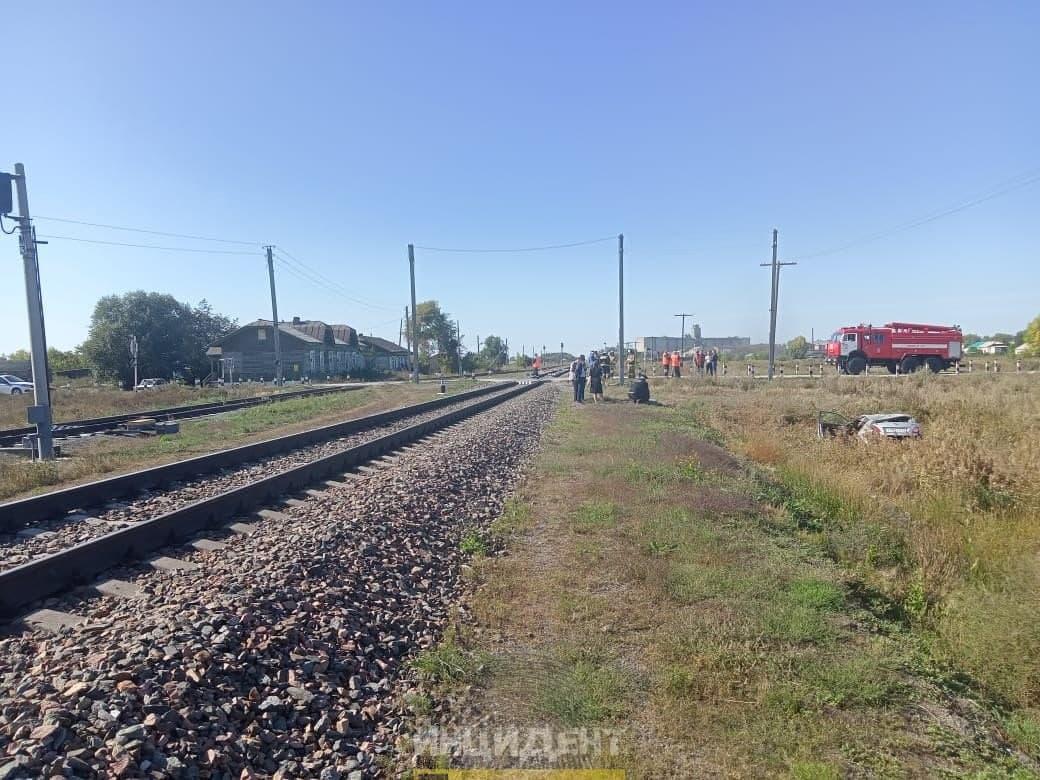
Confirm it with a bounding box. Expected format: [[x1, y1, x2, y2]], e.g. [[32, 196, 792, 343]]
[[0, 383, 536, 618]]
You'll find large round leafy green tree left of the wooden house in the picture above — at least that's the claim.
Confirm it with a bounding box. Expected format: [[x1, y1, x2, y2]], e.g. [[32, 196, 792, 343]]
[[82, 290, 234, 387]]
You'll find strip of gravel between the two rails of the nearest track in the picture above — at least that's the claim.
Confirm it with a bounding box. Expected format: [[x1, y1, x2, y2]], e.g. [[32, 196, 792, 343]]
[[0, 386, 520, 571]]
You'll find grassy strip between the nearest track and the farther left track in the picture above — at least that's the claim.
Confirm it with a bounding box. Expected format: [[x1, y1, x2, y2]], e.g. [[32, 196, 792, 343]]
[[0, 380, 477, 500]]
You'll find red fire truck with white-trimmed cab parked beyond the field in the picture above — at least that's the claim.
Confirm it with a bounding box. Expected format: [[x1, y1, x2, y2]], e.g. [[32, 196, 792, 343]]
[[827, 322, 961, 373]]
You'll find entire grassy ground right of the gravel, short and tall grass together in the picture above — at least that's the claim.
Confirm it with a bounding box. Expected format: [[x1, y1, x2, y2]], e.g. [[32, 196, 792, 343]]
[[414, 374, 1040, 778]]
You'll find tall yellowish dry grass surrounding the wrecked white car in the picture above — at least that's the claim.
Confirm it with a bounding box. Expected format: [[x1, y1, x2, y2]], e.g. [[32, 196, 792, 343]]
[[658, 373, 1040, 728]]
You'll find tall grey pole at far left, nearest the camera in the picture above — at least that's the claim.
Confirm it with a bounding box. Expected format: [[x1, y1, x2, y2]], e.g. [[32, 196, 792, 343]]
[[11, 162, 54, 461]]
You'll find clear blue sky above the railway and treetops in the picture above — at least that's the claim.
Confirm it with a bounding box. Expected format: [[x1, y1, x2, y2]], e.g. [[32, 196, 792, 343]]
[[0, 0, 1040, 352]]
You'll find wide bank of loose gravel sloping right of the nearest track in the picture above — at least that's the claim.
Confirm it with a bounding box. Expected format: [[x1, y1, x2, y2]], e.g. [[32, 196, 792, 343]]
[[0, 386, 558, 780]]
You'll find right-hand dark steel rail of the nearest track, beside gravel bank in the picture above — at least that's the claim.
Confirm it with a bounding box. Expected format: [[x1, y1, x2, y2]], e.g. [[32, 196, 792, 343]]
[[0, 383, 541, 618]]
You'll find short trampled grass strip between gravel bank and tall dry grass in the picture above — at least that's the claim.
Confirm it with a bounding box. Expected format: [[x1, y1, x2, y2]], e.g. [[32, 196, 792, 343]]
[[440, 385, 1040, 778]]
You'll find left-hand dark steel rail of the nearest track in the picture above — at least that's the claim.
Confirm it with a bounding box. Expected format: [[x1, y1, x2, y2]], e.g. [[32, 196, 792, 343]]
[[0, 382, 516, 532]]
